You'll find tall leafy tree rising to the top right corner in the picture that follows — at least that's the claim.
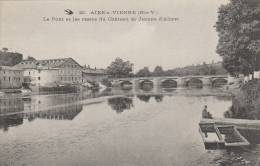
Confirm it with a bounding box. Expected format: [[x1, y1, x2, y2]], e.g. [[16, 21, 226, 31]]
[[216, 0, 260, 76]]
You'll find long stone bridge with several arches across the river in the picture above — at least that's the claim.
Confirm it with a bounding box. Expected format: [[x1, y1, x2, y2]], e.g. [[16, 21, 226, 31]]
[[112, 75, 231, 88]]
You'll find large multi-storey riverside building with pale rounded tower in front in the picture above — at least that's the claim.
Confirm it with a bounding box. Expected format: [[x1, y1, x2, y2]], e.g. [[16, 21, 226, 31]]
[[16, 58, 83, 86]]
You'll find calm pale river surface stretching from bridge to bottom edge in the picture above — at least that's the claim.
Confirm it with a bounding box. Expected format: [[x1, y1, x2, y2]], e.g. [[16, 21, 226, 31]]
[[0, 89, 231, 166]]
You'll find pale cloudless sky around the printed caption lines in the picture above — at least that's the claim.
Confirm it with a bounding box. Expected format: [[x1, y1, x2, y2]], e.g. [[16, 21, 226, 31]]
[[0, 0, 227, 71]]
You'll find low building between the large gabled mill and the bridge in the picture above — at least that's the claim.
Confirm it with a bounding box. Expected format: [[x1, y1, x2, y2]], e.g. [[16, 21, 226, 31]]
[[82, 67, 108, 82]]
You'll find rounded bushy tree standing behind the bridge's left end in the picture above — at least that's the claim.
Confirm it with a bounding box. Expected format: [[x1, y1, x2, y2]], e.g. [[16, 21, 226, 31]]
[[107, 58, 133, 78]]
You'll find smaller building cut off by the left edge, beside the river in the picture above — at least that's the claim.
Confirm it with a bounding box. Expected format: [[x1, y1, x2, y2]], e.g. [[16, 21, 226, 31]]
[[0, 66, 23, 89]]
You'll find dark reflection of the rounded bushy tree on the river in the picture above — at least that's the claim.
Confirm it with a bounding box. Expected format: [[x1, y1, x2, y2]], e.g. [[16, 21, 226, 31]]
[[108, 97, 134, 113]]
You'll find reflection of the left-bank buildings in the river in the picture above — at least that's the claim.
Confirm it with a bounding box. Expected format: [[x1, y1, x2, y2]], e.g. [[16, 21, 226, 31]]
[[0, 93, 99, 131]]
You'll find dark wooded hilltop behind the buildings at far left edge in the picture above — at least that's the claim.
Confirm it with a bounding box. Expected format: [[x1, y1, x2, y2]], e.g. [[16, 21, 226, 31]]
[[0, 51, 23, 66]]
